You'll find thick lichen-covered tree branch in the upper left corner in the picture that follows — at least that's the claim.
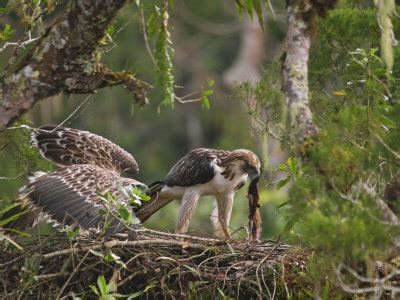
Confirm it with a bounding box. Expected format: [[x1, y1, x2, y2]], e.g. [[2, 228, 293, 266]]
[[0, 0, 148, 131]]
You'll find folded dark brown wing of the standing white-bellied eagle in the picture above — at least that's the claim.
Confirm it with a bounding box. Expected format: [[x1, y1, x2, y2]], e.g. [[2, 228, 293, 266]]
[[163, 148, 228, 186]]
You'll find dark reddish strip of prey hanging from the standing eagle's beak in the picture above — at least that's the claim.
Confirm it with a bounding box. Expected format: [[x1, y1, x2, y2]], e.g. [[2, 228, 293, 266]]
[[247, 180, 261, 243]]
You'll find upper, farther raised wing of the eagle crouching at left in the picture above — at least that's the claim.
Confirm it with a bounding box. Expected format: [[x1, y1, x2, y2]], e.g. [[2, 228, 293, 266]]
[[32, 125, 139, 173]]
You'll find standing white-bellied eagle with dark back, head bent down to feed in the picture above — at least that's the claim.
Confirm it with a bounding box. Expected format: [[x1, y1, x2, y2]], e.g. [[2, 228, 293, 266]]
[[136, 148, 261, 238]]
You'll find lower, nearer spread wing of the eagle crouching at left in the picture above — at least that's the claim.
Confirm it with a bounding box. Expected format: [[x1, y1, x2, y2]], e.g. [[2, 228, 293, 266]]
[[20, 165, 147, 231]]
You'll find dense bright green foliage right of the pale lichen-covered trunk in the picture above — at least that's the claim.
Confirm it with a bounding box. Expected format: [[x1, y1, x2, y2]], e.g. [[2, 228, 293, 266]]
[[286, 9, 400, 294]]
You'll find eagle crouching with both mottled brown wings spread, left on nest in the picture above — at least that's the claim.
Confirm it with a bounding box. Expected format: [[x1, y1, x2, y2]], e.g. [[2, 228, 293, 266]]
[[9, 125, 148, 232]]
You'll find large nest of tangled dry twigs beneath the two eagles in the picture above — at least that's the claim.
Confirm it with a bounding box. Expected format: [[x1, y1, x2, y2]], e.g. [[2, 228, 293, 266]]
[[0, 229, 308, 299]]
